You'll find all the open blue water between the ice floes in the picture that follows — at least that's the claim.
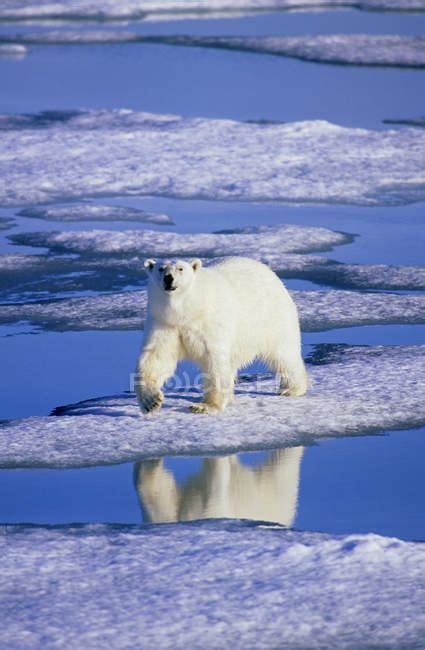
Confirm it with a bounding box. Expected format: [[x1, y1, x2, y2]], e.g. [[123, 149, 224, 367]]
[[0, 11, 425, 539]]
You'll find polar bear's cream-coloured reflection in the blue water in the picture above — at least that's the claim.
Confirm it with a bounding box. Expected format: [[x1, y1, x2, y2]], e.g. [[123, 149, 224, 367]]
[[134, 447, 303, 526]]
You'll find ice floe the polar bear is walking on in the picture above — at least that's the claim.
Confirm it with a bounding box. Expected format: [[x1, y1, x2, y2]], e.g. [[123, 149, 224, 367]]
[[0, 346, 425, 467]]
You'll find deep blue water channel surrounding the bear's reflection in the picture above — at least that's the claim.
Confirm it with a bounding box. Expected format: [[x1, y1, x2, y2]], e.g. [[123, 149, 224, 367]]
[[0, 429, 425, 540]]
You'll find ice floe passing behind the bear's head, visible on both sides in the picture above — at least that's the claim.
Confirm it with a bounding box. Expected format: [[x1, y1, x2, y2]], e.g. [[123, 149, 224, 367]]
[[0, 254, 425, 303]]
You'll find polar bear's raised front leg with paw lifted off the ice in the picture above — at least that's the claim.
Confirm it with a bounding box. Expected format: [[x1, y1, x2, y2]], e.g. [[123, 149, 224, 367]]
[[134, 328, 179, 413]]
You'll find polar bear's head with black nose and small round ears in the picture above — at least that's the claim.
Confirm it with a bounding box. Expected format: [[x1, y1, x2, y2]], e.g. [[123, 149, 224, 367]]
[[144, 259, 202, 295]]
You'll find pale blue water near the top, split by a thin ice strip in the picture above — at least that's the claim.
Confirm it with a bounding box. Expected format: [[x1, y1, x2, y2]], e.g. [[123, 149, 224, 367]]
[[0, 12, 425, 129]]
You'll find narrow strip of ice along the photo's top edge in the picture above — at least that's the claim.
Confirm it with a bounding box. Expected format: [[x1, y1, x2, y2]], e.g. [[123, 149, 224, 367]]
[[0, 0, 425, 22]]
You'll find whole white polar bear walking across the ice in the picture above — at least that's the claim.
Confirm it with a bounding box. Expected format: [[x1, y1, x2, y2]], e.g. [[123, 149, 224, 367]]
[[135, 257, 307, 413]]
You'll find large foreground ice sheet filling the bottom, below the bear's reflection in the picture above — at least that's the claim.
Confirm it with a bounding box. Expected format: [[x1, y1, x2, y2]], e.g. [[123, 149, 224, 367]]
[[0, 521, 425, 650]]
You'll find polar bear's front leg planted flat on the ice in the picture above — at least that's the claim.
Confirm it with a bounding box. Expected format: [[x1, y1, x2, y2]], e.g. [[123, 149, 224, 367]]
[[190, 351, 235, 413]]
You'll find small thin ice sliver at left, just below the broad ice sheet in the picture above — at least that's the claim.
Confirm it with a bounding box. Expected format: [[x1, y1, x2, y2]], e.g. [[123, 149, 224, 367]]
[[18, 203, 173, 225]]
